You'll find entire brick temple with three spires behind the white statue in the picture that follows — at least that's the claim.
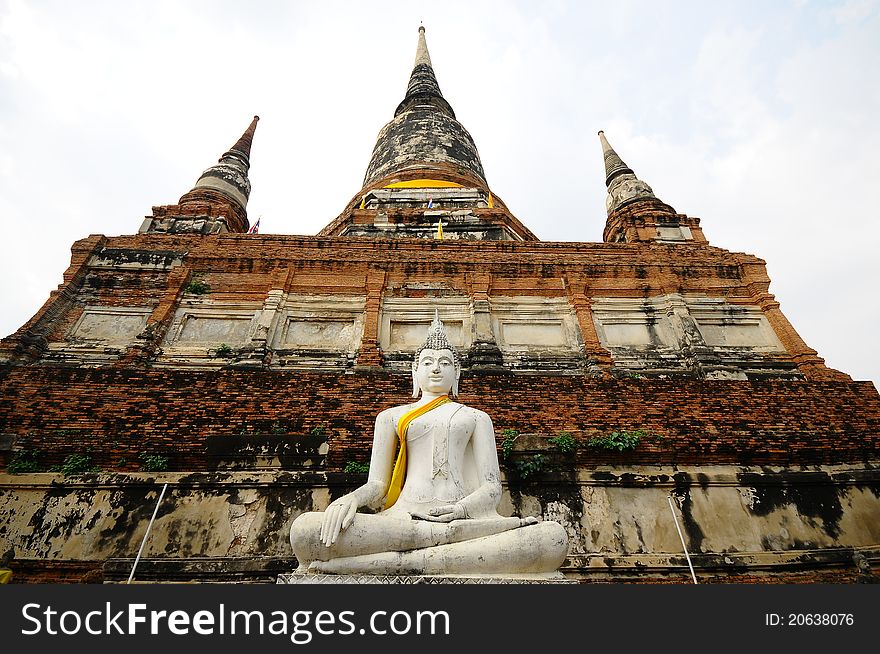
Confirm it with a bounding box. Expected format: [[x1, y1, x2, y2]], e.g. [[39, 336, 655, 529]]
[[0, 28, 880, 582]]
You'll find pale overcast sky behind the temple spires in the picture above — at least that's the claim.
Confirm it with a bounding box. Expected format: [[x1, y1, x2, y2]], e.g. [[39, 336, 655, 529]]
[[0, 0, 880, 384]]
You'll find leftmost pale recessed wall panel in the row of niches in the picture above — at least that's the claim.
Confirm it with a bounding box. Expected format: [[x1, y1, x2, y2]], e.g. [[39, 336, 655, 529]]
[[48, 306, 153, 366]]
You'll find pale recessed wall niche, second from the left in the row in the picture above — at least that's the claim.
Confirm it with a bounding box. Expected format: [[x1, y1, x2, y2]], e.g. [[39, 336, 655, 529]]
[[156, 299, 261, 367]]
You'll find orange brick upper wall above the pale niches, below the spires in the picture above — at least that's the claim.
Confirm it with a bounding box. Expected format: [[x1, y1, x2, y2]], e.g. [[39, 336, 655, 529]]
[[0, 234, 848, 381]]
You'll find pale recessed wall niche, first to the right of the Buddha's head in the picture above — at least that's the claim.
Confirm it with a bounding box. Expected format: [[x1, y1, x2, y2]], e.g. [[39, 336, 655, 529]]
[[489, 296, 583, 373]]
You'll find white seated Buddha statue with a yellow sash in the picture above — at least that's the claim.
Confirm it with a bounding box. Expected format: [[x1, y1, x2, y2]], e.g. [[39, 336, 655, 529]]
[[290, 317, 568, 576]]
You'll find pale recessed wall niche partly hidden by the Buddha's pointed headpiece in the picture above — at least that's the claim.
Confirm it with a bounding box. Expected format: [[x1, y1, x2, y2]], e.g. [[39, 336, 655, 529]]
[[379, 296, 473, 371]]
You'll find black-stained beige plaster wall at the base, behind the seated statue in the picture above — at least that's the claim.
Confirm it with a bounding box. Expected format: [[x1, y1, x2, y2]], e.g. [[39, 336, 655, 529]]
[[0, 466, 880, 571]]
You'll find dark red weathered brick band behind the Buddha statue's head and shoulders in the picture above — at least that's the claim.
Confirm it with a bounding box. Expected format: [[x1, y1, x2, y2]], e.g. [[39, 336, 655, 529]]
[[0, 366, 880, 471]]
